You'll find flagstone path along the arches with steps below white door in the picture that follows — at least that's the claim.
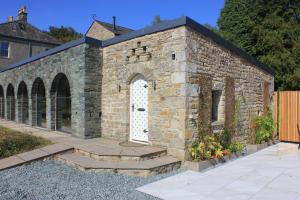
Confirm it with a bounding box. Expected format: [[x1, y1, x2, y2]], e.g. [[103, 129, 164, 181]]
[[0, 120, 181, 176]]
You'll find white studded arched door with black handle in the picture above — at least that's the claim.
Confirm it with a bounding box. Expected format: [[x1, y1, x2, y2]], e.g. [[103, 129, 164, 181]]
[[130, 75, 149, 142]]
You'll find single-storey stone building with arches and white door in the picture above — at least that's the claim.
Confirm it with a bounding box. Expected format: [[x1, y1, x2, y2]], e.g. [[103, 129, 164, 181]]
[[0, 17, 274, 159]]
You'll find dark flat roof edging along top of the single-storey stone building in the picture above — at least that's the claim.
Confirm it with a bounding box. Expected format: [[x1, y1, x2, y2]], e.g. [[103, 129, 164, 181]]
[[0, 17, 275, 75]]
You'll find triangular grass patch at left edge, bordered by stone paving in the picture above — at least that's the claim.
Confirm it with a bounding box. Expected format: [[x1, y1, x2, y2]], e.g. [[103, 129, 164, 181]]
[[0, 126, 52, 159]]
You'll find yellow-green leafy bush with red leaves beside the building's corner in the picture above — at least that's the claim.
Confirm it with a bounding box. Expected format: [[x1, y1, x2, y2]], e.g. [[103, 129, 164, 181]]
[[190, 135, 223, 160]]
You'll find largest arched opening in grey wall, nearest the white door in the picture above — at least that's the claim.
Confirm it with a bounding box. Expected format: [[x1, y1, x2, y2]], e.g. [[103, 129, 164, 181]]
[[50, 73, 72, 133]]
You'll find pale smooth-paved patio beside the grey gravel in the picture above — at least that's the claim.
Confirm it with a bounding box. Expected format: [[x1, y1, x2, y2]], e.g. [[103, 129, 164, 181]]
[[137, 143, 300, 200]]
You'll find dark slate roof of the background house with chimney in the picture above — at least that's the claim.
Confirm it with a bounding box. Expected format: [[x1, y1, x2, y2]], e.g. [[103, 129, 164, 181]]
[[0, 21, 61, 45]]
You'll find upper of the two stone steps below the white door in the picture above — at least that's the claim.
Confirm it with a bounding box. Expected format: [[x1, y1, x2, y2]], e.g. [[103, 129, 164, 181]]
[[75, 146, 167, 161]]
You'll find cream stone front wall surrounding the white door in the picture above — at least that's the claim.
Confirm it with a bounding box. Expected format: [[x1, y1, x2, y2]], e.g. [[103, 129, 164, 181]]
[[101, 27, 188, 158]]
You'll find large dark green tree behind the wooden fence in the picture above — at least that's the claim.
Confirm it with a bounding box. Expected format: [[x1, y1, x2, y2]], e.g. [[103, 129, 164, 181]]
[[218, 0, 300, 90]]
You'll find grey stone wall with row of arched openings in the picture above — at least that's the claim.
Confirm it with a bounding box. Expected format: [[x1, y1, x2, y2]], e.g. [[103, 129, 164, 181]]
[[0, 44, 101, 138]]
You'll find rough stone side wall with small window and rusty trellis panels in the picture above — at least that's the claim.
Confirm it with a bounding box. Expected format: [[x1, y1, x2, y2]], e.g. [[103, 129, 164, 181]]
[[186, 28, 274, 144]]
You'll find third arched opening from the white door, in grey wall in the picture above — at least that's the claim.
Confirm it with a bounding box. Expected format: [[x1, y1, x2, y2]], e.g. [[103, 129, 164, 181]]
[[17, 81, 29, 124]]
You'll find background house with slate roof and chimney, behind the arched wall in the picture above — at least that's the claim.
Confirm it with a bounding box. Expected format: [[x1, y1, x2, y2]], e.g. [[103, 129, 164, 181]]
[[0, 7, 61, 67]]
